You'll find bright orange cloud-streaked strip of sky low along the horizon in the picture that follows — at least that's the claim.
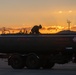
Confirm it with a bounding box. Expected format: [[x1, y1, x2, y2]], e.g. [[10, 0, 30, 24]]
[[0, 26, 76, 34]]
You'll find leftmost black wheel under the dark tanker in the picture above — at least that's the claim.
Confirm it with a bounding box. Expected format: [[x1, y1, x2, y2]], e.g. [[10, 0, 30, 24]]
[[8, 55, 25, 69]]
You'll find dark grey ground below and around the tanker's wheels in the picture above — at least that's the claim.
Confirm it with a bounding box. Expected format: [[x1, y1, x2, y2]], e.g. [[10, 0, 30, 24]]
[[0, 59, 76, 75]]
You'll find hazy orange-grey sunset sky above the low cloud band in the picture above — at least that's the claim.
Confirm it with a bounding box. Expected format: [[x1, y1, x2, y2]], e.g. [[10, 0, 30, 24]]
[[0, 0, 76, 33]]
